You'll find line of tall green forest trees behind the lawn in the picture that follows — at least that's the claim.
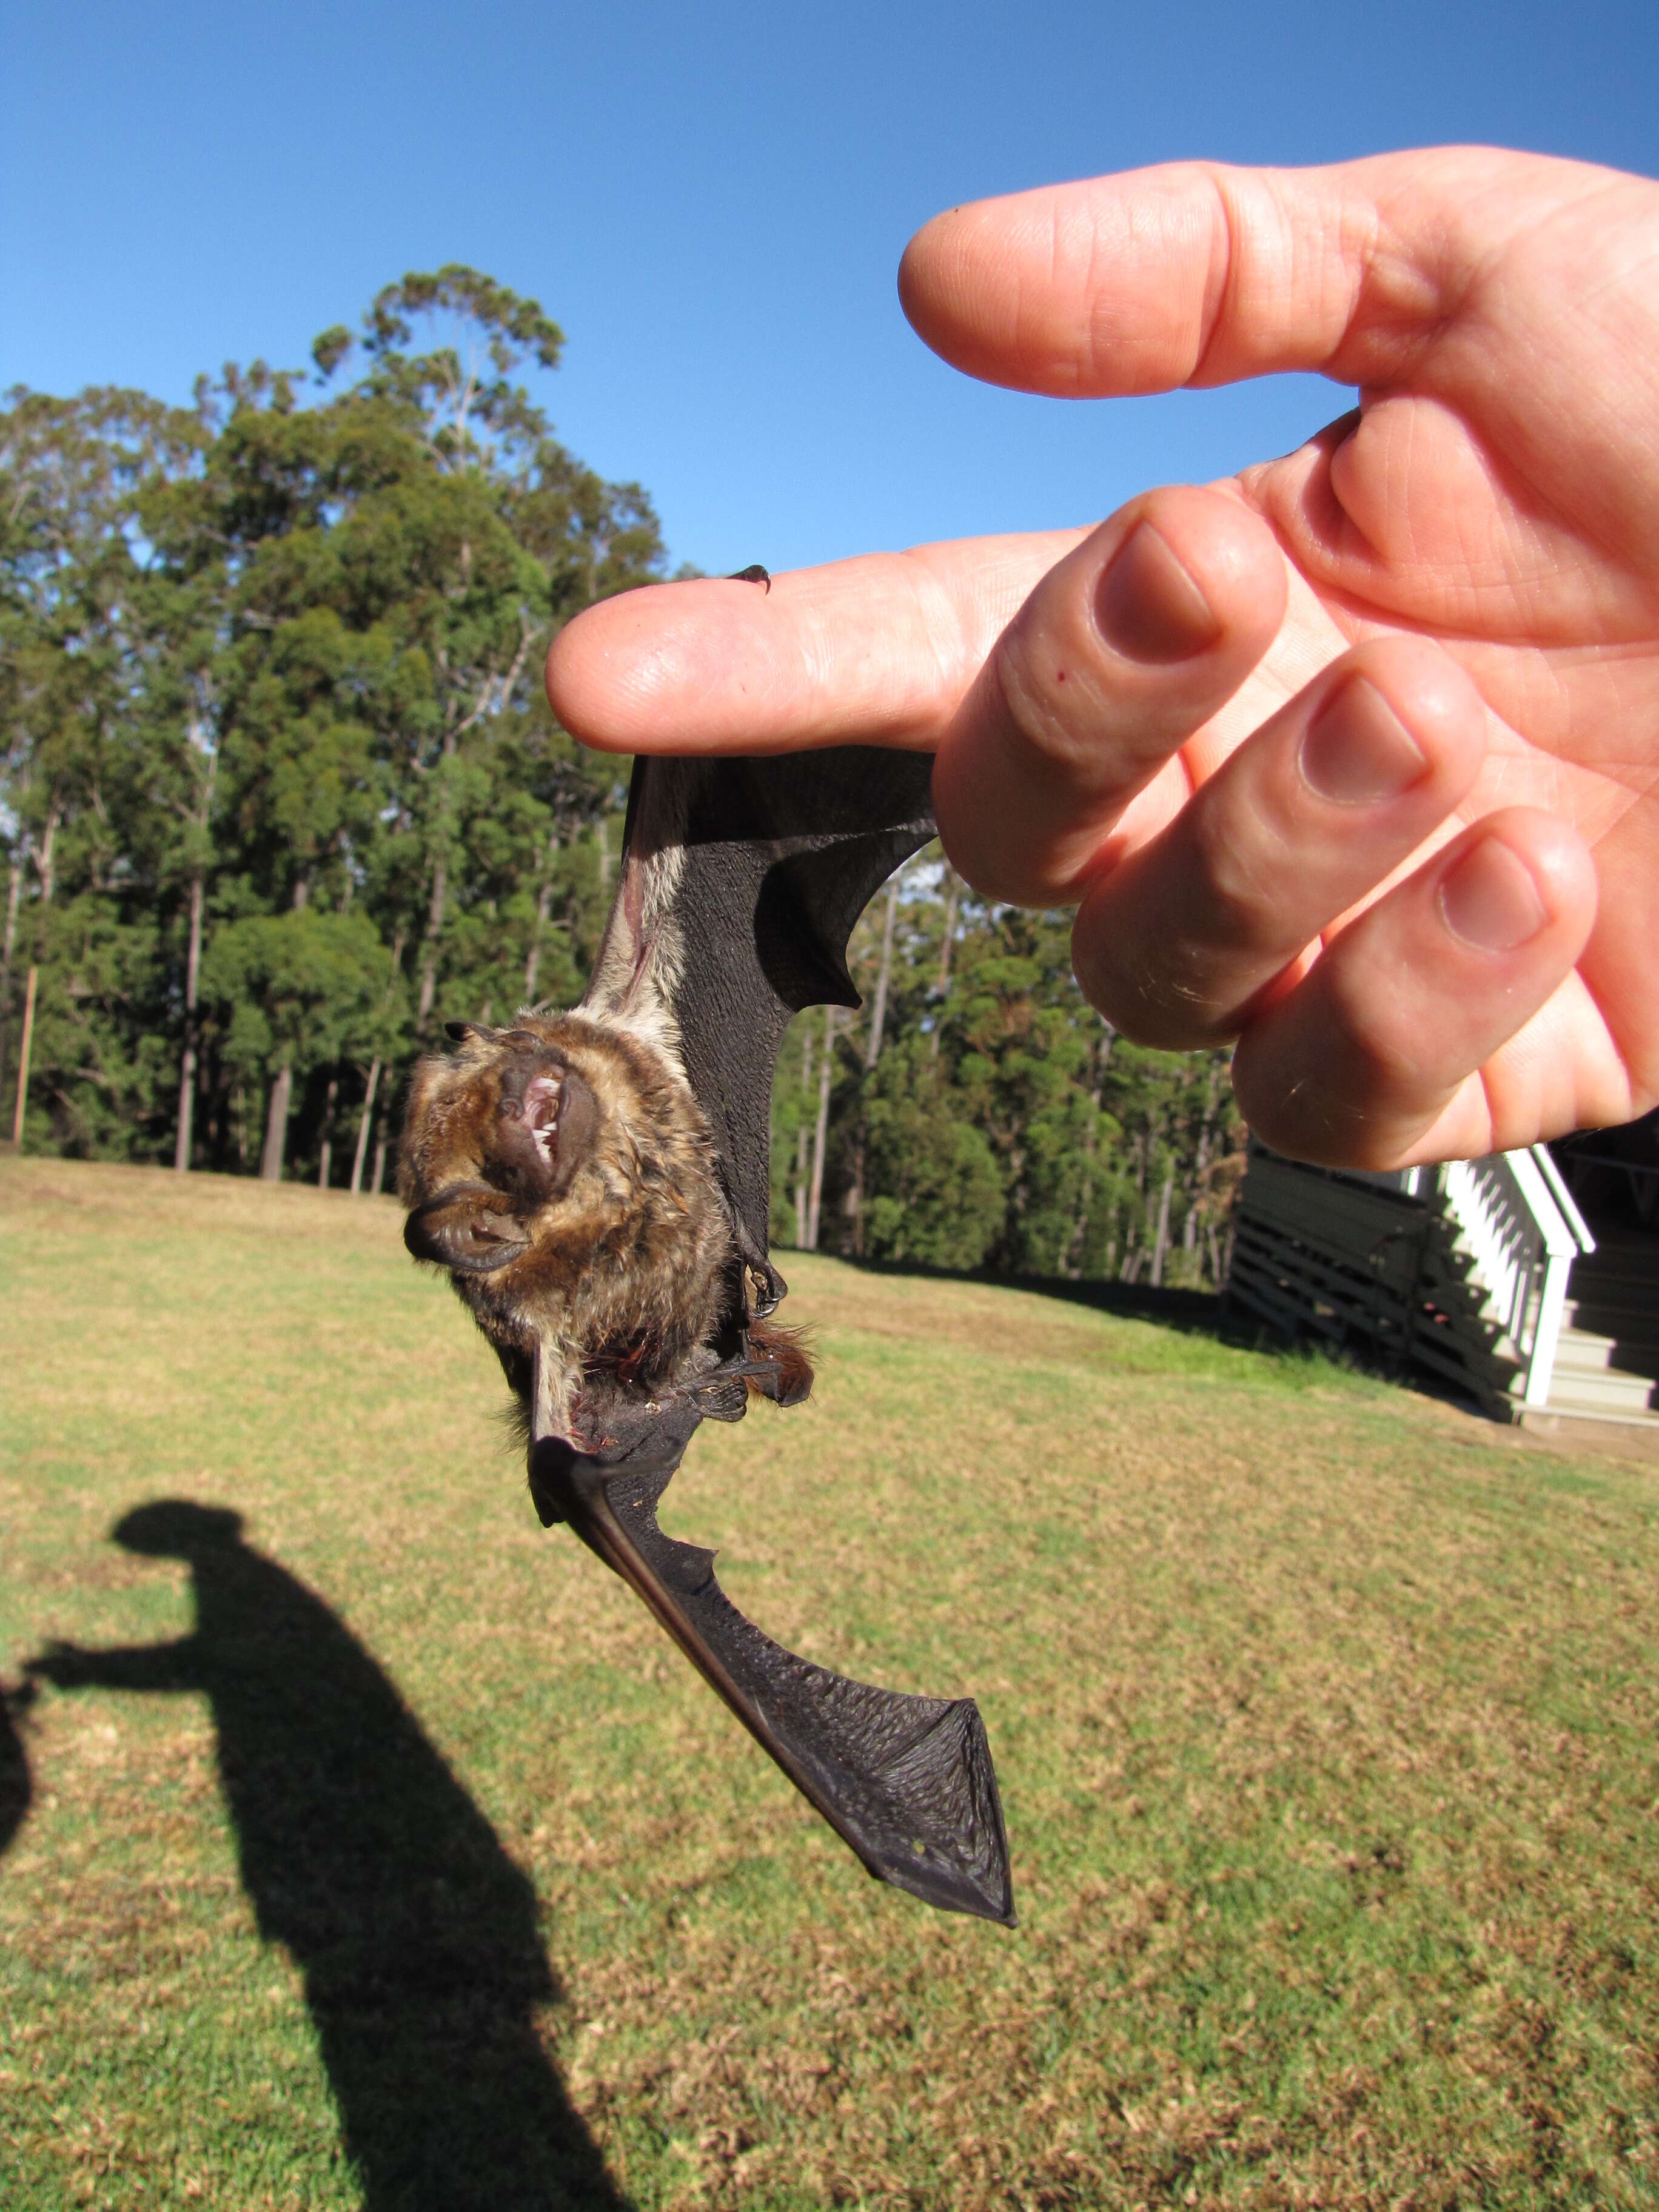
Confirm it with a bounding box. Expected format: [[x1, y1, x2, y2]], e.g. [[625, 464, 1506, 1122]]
[[0, 267, 1243, 1281]]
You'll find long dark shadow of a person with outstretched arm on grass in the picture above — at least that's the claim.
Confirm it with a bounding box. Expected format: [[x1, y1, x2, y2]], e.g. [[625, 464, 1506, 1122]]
[[28, 1500, 626, 2212]]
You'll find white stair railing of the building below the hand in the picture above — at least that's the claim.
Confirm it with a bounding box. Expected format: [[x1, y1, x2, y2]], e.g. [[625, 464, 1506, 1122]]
[[1438, 1144, 1595, 1404]]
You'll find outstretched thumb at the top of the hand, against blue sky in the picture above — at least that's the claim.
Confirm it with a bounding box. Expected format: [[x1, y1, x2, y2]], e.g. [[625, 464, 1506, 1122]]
[[898, 146, 1610, 396]]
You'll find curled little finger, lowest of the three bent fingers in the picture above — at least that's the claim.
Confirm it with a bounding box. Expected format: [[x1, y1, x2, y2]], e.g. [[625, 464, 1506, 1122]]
[[1232, 808, 1595, 1168]]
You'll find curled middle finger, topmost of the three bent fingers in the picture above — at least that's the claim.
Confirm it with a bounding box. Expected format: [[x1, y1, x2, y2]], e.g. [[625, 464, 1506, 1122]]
[[933, 484, 1285, 905]]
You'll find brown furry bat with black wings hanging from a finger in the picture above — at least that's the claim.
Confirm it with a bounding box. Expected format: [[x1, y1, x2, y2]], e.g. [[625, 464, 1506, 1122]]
[[400, 745, 1013, 1926]]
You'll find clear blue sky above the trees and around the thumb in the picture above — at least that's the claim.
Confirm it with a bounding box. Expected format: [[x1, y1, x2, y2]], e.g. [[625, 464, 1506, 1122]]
[[0, 0, 1659, 569]]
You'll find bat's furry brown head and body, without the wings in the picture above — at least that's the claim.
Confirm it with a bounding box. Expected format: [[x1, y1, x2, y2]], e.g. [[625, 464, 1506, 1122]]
[[400, 1013, 732, 1436]]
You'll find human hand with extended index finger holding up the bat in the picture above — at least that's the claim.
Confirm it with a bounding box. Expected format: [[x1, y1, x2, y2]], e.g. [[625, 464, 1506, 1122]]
[[549, 148, 1659, 1168]]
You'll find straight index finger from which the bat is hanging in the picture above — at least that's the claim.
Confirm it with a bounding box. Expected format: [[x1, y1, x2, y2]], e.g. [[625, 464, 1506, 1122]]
[[546, 531, 1084, 752]]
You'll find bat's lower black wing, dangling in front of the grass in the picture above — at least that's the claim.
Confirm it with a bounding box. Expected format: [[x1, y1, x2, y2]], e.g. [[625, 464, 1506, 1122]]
[[531, 1403, 1013, 1926]]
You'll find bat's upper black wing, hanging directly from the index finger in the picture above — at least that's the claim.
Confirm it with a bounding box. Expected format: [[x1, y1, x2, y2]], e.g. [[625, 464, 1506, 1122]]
[[581, 745, 933, 1281]]
